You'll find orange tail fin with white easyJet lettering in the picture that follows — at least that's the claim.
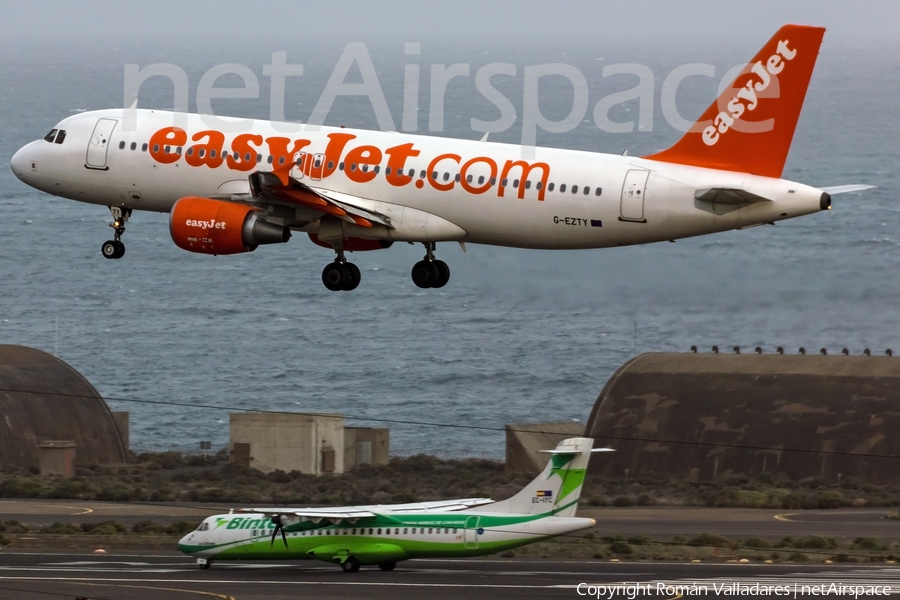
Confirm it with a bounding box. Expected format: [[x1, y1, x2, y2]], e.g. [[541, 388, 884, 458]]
[[644, 25, 825, 177]]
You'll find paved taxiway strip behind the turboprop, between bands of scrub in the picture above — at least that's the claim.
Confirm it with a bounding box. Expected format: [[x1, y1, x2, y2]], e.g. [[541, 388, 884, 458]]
[[0, 499, 900, 543]]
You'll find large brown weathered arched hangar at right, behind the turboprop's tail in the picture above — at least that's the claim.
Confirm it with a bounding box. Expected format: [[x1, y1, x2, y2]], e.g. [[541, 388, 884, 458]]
[[585, 353, 900, 482]]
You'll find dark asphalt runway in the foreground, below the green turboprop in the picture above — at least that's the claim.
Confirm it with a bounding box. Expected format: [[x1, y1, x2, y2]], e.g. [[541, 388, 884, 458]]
[[0, 551, 900, 600]]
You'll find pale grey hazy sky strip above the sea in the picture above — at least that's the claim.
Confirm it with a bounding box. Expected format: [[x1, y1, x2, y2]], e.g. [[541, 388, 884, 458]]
[[0, 0, 900, 47]]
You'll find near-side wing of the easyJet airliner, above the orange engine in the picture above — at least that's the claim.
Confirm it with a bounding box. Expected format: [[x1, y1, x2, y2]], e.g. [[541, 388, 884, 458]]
[[250, 171, 391, 227]]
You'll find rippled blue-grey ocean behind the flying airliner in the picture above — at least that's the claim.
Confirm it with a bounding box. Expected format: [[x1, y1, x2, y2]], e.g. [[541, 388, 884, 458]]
[[0, 30, 900, 456]]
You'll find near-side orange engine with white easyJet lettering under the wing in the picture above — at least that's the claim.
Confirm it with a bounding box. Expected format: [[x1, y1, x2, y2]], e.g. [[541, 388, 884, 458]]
[[169, 196, 291, 254]]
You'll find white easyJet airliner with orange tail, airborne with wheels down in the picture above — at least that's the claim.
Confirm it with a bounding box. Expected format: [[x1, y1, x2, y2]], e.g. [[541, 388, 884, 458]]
[[11, 25, 871, 291]]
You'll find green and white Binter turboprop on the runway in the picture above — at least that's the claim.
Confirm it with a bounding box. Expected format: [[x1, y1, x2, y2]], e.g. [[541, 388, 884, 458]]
[[178, 438, 609, 573]]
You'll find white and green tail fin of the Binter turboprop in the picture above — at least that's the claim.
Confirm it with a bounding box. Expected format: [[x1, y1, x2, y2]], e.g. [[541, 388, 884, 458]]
[[478, 438, 611, 517]]
